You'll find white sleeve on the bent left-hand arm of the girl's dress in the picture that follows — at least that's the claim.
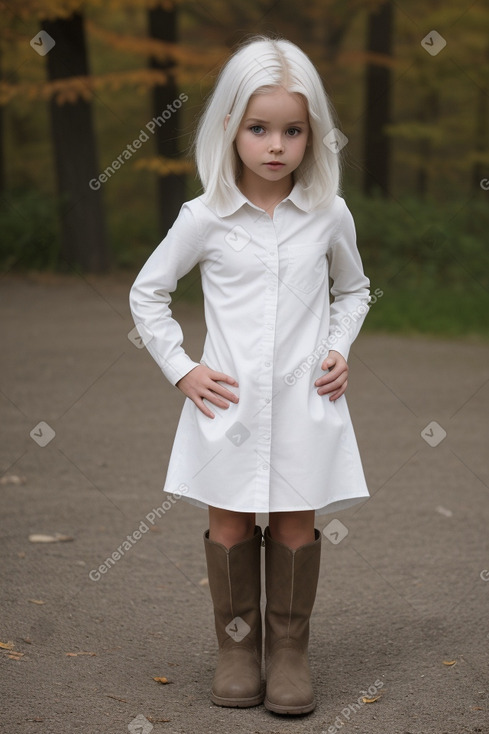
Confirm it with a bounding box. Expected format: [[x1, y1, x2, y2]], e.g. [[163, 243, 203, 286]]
[[129, 204, 202, 385]]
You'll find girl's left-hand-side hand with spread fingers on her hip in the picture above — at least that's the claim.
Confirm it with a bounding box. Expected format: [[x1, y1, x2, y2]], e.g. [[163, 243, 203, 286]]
[[176, 364, 239, 418]]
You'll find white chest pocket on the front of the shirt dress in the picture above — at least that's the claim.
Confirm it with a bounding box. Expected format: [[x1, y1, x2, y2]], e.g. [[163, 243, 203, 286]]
[[285, 242, 327, 293]]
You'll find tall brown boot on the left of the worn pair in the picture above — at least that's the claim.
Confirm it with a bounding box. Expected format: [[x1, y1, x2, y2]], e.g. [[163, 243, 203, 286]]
[[204, 526, 265, 708]]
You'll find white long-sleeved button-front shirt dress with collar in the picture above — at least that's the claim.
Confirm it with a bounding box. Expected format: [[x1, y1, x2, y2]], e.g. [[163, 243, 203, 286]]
[[130, 184, 369, 515]]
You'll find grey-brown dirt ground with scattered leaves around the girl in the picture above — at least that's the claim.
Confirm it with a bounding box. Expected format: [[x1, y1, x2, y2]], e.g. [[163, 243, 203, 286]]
[[0, 276, 489, 734]]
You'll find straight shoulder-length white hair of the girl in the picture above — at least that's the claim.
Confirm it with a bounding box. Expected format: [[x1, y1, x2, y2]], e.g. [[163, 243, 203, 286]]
[[195, 36, 340, 208]]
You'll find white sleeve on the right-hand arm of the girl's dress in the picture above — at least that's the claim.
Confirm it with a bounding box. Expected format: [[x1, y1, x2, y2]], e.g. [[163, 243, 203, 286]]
[[328, 199, 370, 359]]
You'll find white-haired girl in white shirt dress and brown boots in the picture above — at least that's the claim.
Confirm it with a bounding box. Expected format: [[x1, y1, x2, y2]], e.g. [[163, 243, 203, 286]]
[[130, 37, 369, 714]]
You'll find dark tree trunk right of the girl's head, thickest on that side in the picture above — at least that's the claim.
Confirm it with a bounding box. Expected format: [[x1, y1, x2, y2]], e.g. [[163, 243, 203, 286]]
[[363, 0, 394, 197]]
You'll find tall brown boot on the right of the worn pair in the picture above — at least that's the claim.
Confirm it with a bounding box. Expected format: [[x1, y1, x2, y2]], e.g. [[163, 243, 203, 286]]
[[265, 528, 321, 714]]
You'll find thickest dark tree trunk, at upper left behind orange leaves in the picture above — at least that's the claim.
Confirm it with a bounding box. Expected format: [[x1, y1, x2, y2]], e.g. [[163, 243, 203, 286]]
[[42, 13, 109, 272]]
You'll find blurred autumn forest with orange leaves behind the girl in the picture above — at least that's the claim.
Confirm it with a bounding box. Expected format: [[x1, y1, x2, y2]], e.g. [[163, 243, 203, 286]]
[[0, 0, 489, 337]]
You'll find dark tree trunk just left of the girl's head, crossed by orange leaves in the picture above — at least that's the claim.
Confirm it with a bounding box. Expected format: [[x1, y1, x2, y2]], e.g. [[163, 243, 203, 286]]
[[148, 7, 185, 237]]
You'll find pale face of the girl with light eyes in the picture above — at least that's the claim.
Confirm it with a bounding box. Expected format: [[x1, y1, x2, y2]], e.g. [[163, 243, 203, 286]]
[[235, 87, 310, 191]]
